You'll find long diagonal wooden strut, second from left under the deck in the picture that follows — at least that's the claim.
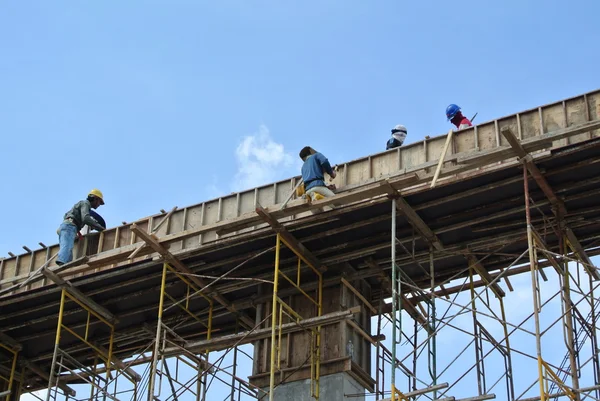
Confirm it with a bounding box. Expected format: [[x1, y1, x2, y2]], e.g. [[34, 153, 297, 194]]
[[131, 224, 254, 327]]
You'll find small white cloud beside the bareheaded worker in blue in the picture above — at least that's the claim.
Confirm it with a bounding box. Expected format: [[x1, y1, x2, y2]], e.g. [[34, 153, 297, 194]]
[[232, 125, 300, 191]]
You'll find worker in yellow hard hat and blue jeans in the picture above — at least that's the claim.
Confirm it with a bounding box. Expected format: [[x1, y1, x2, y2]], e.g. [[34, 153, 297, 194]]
[[56, 189, 106, 266]]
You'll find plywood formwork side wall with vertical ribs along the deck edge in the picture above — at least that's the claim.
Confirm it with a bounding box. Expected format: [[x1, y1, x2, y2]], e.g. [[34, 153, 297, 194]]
[[0, 91, 600, 289]]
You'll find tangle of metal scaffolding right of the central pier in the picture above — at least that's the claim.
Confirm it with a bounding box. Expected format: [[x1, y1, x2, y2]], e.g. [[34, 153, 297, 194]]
[[374, 165, 600, 401]]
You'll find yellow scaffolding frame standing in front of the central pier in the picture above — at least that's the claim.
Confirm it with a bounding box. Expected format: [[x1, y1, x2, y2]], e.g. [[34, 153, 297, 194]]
[[269, 233, 323, 401]]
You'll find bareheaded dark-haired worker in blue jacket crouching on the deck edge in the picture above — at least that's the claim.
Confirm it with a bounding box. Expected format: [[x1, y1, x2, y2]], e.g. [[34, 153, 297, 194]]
[[300, 146, 335, 200]]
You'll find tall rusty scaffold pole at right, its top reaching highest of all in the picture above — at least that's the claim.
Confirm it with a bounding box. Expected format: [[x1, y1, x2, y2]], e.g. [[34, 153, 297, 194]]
[[523, 164, 548, 401]]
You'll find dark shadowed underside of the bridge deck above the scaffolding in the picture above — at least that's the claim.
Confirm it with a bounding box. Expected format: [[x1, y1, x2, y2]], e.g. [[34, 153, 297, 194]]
[[0, 133, 600, 387]]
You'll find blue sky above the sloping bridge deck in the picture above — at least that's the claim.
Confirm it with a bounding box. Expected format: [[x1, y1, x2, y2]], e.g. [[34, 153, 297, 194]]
[[0, 0, 600, 396]]
